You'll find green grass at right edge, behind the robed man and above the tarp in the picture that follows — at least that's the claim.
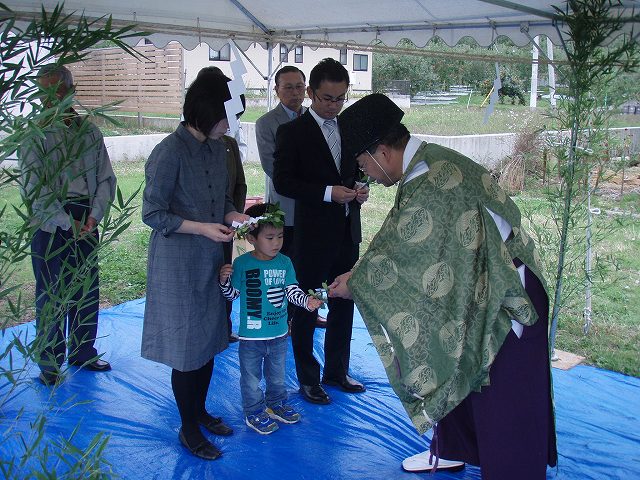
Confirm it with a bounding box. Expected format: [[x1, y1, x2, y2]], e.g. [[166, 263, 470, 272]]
[[515, 189, 640, 376]]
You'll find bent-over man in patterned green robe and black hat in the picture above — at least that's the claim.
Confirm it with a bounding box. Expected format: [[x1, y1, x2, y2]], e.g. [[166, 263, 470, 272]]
[[330, 94, 557, 480]]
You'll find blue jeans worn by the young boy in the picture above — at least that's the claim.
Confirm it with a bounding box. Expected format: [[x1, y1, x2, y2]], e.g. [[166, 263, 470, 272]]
[[238, 335, 288, 416]]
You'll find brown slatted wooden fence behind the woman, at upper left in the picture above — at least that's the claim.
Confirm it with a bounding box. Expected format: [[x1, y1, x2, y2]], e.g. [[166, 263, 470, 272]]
[[69, 42, 184, 114]]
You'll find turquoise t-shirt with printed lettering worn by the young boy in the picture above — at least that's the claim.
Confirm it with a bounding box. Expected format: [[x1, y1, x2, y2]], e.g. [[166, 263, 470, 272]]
[[231, 252, 298, 340]]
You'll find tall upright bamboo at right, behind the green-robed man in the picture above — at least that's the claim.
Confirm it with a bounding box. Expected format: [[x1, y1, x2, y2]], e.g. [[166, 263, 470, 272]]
[[547, 0, 640, 349]]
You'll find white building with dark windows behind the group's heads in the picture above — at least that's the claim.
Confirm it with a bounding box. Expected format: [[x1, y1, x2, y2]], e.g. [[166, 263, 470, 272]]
[[184, 43, 372, 94]]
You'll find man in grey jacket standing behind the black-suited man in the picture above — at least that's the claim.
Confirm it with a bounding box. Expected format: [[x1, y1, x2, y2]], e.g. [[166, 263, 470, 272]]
[[256, 65, 327, 328]]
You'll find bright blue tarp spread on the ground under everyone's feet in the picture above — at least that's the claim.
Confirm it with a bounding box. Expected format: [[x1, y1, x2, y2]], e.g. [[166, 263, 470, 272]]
[[0, 300, 640, 480]]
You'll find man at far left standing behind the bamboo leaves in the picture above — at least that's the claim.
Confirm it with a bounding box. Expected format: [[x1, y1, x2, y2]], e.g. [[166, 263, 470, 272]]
[[20, 64, 116, 385]]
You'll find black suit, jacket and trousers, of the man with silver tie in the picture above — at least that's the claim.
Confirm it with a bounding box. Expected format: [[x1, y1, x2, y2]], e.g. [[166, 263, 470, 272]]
[[273, 110, 362, 386]]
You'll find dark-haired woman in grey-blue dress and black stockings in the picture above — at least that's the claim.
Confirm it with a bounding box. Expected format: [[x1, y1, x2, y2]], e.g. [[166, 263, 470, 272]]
[[142, 75, 248, 460]]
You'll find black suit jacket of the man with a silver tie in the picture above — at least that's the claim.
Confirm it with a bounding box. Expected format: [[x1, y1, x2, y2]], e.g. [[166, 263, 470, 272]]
[[273, 111, 362, 257]]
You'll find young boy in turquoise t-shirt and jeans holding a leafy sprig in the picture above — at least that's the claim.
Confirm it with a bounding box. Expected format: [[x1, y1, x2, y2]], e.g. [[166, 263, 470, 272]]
[[220, 203, 322, 435]]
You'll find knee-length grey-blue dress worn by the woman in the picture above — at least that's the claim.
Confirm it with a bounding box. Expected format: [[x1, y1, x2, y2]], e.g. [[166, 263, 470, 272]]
[[142, 125, 235, 372]]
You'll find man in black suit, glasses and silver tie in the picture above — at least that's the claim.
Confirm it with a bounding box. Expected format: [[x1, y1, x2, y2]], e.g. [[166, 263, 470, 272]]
[[273, 58, 369, 404]]
